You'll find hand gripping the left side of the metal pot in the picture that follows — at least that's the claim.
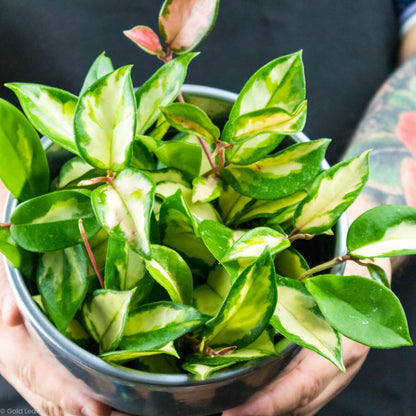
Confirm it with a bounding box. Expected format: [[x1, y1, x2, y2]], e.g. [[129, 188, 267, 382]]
[[0, 182, 128, 416]]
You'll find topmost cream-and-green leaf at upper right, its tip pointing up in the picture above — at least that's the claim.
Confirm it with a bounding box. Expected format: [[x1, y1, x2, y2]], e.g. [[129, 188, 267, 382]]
[[229, 51, 305, 120]]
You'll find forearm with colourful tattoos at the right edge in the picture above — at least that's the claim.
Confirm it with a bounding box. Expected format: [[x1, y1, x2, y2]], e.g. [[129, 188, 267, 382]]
[[346, 58, 416, 207]]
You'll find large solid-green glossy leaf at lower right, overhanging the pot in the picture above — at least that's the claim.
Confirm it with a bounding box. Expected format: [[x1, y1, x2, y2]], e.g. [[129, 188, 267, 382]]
[[306, 275, 412, 348]]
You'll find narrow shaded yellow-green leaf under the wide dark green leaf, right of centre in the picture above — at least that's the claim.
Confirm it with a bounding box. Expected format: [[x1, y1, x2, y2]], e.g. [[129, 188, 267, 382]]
[[235, 190, 307, 224]]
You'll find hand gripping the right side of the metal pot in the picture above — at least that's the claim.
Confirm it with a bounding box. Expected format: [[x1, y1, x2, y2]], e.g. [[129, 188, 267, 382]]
[[223, 259, 390, 416]]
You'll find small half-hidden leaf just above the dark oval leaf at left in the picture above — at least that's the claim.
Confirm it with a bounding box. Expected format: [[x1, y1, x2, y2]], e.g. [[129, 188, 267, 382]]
[[56, 156, 107, 189]]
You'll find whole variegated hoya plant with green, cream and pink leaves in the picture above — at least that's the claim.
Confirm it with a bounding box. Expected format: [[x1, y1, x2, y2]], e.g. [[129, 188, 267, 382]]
[[0, 0, 416, 378]]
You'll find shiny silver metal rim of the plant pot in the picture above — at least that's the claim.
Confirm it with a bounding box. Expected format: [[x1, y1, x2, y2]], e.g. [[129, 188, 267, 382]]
[[2, 84, 348, 387]]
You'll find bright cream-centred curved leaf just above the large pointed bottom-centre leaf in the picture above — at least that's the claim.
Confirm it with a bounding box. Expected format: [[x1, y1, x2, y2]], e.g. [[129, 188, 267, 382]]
[[220, 227, 290, 280]]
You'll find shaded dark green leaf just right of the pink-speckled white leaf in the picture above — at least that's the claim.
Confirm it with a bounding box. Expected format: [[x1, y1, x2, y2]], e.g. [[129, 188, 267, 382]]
[[159, 190, 215, 270]]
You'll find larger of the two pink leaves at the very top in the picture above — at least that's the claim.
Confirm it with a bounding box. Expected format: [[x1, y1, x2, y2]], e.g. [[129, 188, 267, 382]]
[[159, 0, 219, 54]]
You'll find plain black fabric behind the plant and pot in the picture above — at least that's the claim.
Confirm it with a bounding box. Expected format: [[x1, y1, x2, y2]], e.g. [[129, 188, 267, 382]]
[[0, 0, 416, 416]]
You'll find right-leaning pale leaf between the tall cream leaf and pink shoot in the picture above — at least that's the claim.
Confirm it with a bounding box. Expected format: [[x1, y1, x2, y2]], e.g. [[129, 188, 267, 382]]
[[135, 53, 197, 134]]
